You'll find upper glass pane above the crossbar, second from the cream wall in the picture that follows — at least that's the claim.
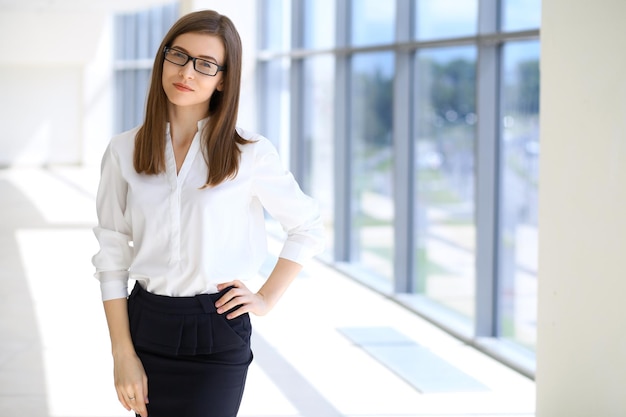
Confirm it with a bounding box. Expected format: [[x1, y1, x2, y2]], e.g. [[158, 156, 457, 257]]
[[415, 0, 478, 40]]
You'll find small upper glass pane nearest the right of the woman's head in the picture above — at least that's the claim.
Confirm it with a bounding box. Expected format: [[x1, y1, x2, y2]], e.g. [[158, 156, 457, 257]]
[[260, 0, 291, 51]]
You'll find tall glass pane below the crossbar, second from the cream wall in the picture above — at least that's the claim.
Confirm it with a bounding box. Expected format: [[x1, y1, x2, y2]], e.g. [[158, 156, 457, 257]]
[[414, 46, 477, 318]]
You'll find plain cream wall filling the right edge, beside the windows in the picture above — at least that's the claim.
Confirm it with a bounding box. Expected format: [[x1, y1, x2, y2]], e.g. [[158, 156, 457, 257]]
[[537, 0, 626, 417]]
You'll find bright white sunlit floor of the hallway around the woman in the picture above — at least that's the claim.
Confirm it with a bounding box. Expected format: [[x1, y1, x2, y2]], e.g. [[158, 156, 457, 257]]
[[0, 167, 535, 417]]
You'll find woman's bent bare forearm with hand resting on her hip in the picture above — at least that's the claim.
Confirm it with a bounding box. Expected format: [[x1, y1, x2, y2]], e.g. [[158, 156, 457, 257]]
[[215, 258, 302, 319]]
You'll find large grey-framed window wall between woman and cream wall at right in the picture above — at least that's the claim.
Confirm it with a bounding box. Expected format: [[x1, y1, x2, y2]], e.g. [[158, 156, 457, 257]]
[[259, 0, 541, 370]]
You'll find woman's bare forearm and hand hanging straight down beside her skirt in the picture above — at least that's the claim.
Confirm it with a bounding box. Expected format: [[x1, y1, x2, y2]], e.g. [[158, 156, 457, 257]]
[[104, 298, 148, 417]]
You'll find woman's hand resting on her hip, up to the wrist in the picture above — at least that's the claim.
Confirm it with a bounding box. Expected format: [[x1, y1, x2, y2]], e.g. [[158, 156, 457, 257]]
[[215, 280, 271, 320]]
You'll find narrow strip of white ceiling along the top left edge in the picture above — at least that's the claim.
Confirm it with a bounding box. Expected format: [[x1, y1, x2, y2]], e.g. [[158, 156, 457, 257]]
[[0, 0, 173, 13]]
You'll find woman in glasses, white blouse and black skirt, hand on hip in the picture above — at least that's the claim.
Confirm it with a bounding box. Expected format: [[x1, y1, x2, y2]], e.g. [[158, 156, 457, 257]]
[[93, 11, 323, 417]]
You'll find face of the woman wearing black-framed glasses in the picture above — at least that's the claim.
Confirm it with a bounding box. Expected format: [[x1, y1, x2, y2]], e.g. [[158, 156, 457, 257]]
[[162, 33, 225, 117]]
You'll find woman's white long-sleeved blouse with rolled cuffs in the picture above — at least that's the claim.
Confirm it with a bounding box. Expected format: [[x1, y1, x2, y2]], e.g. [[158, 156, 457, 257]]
[[92, 119, 324, 300]]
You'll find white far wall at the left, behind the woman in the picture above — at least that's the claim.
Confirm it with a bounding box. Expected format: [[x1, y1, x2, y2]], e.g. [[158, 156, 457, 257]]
[[0, 11, 110, 166]]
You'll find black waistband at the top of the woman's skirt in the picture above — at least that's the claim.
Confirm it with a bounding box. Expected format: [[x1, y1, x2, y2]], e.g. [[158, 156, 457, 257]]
[[129, 282, 233, 314]]
